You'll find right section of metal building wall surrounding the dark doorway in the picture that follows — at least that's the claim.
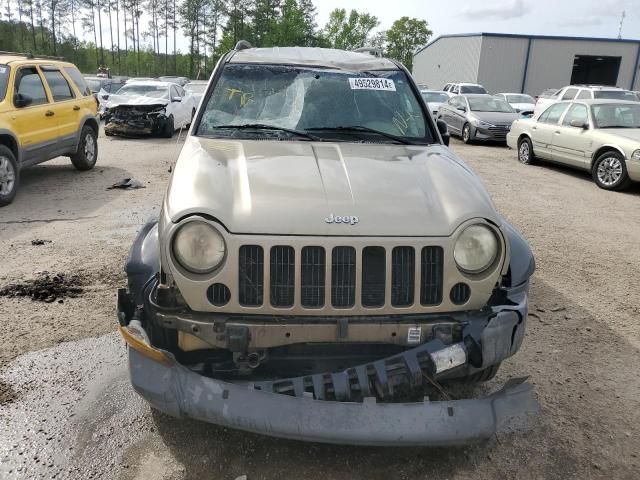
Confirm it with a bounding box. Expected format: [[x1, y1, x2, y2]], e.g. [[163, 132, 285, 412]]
[[525, 38, 638, 95]]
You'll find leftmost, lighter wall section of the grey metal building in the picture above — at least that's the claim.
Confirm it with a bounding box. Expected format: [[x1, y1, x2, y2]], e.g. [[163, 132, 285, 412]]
[[413, 35, 482, 90]]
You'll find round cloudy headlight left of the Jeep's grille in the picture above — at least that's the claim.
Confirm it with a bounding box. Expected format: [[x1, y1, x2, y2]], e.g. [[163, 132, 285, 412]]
[[173, 221, 227, 273]]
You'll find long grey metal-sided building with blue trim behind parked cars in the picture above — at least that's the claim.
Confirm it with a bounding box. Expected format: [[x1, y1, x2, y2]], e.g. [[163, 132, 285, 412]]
[[413, 33, 640, 95]]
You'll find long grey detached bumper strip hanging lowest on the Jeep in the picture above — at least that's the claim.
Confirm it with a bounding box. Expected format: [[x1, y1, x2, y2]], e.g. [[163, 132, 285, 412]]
[[129, 348, 539, 446]]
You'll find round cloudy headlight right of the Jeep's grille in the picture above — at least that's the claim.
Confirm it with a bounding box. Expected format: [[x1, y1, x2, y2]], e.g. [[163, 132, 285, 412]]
[[453, 225, 498, 273]]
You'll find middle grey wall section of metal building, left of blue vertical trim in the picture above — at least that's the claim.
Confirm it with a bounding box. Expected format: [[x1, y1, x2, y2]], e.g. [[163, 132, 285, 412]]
[[478, 36, 529, 93]]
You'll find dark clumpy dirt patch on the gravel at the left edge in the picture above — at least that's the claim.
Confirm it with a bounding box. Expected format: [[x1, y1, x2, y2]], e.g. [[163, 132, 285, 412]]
[[0, 272, 84, 303]]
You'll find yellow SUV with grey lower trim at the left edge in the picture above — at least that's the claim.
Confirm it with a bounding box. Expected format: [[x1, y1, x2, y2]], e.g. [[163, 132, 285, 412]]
[[0, 52, 98, 206]]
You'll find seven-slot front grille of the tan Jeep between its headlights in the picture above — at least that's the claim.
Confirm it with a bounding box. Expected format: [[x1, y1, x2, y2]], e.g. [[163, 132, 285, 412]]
[[238, 245, 444, 309]]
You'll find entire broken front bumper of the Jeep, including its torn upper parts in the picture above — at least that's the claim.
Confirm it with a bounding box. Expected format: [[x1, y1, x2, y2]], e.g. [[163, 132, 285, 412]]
[[118, 285, 539, 446]]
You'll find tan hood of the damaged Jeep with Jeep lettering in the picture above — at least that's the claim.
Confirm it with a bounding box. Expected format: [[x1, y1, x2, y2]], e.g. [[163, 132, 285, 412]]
[[164, 137, 500, 236]]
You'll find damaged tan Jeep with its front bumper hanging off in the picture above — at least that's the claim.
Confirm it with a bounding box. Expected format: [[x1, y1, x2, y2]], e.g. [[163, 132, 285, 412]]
[[118, 43, 537, 445]]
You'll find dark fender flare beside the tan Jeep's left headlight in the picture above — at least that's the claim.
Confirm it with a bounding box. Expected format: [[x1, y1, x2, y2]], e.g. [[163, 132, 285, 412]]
[[124, 220, 160, 305]]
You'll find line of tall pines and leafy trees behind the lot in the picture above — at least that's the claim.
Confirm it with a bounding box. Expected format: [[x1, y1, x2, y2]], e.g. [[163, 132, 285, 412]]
[[0, 0, 432, 78]]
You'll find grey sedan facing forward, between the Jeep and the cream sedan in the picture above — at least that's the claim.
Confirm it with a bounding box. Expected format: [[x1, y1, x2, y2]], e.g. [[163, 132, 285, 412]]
[[437, 94, 519, 143]]
